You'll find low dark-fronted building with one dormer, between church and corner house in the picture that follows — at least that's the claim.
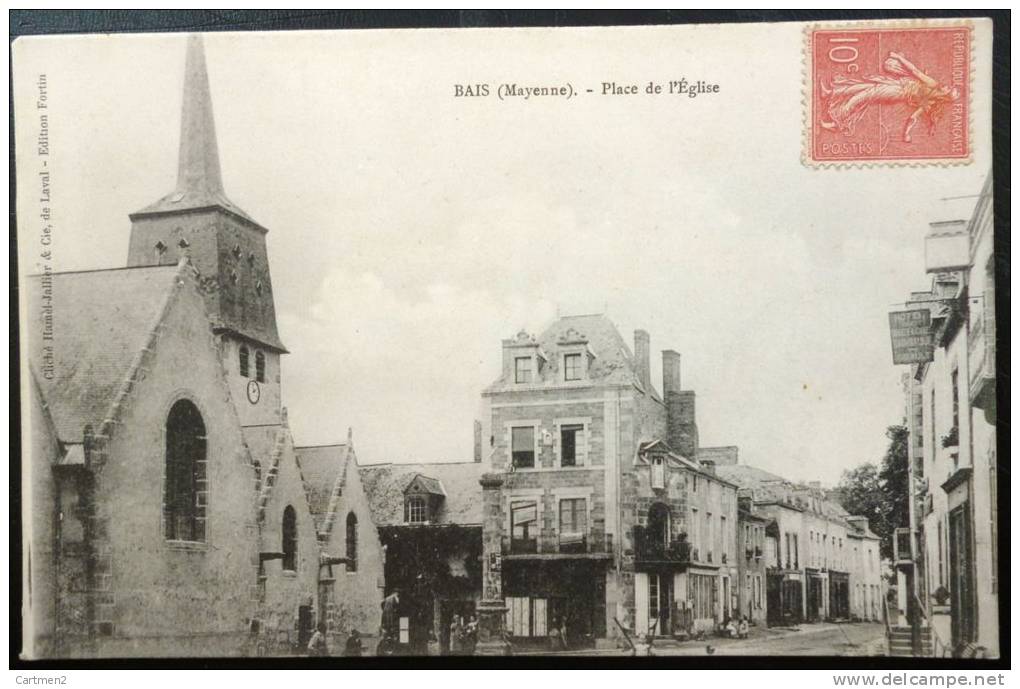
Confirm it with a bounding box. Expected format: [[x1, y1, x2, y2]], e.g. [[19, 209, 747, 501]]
[[360, 461, 487, 655]]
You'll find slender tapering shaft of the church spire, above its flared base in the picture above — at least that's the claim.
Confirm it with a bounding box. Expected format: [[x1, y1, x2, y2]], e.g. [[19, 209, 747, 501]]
[[176, 34, 223, 196]]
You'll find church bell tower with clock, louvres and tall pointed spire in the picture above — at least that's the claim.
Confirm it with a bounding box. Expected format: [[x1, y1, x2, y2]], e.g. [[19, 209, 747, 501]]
[[128, 35, 287, 434]]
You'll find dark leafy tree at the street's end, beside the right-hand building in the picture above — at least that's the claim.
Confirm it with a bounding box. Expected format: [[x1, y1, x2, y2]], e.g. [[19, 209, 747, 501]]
[[835, 426, 910, 559]]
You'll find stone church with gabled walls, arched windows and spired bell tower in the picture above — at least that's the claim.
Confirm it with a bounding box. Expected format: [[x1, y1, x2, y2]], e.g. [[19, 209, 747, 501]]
[[22, 37, 381, 657]]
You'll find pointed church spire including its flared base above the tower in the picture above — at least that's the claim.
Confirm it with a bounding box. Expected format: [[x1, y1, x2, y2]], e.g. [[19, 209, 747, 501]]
[[133, 34, 257, 225]]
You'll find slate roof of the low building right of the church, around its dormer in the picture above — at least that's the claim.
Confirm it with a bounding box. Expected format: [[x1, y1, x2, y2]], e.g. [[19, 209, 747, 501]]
[[358, 461, 489, 527]]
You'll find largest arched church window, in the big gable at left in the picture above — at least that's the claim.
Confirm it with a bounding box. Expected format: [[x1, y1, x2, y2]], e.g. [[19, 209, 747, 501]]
[[163, 399, 206, 541]]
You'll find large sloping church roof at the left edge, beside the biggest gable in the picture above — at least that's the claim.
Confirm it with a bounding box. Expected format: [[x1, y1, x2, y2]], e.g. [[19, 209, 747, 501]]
[[26, 265, 179, 443]]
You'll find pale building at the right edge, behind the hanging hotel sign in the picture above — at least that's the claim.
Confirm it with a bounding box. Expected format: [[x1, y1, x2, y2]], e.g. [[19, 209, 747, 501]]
[[899, 175, 1000, 656]]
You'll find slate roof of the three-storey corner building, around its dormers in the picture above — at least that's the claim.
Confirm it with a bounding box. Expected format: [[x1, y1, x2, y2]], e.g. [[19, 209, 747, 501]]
[[489, 313, 648, 399]]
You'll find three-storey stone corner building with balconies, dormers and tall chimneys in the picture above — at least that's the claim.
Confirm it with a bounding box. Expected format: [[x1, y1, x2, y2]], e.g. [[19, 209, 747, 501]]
[[482, 315, 737, 645]]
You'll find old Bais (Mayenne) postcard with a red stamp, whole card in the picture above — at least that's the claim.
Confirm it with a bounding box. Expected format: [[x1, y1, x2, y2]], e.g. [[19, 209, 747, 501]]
[[12, 17, 995, 667]]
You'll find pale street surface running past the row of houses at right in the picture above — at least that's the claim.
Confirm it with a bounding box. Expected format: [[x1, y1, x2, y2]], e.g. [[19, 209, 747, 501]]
[[554, 624, 885, 655]]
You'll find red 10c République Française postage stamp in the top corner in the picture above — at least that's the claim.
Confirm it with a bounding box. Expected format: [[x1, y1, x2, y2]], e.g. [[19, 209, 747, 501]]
[[805, 24, 971, 164]]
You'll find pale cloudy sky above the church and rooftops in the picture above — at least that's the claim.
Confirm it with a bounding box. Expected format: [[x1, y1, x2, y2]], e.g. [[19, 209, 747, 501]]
[[14, 24, 990, 485]]
